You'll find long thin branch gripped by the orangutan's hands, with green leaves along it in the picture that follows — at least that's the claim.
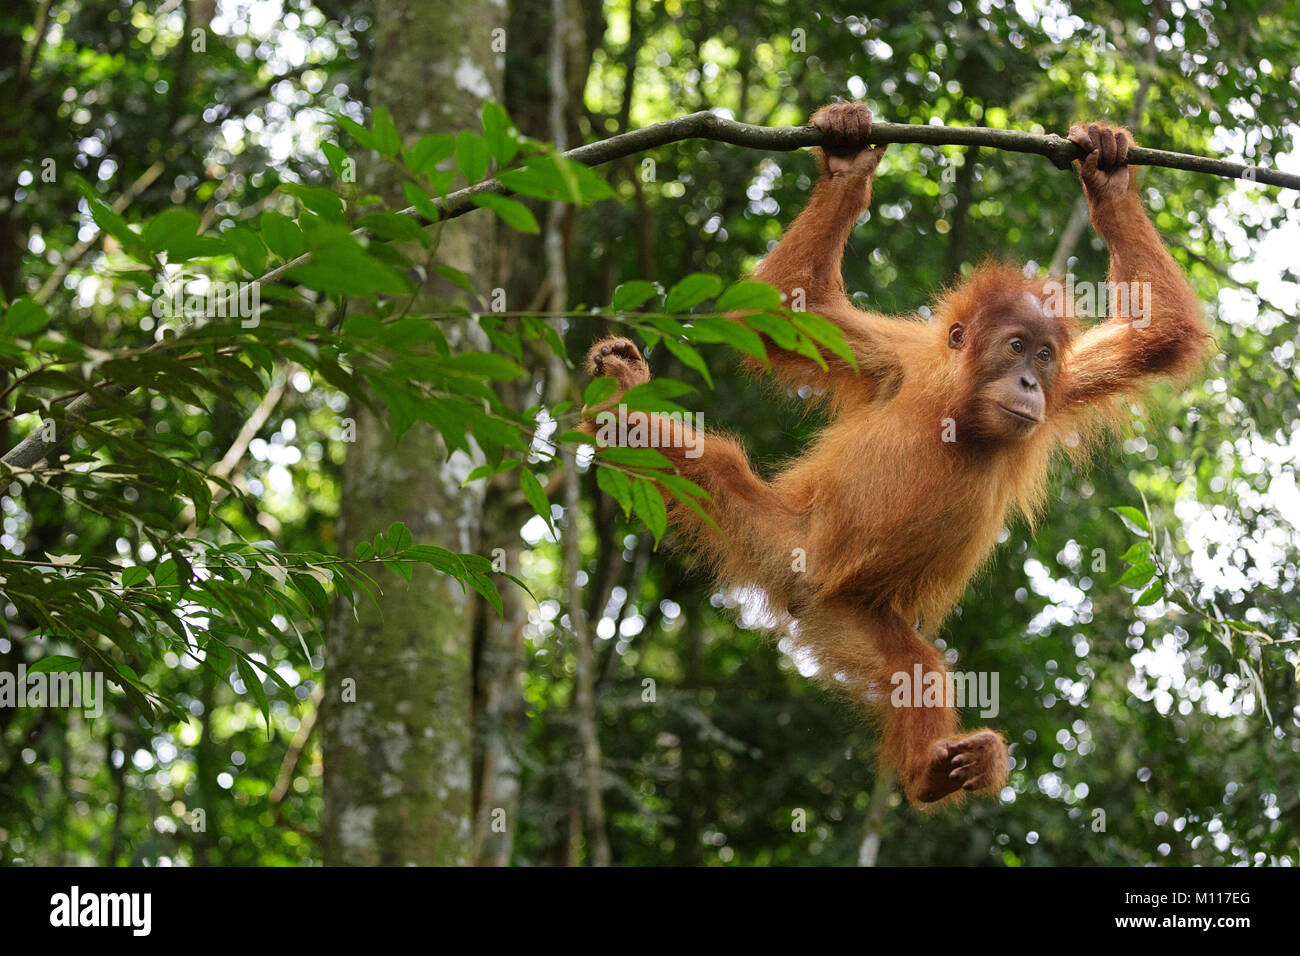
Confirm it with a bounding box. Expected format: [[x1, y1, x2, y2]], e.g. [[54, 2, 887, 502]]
[[3, 103, 1300, 467]]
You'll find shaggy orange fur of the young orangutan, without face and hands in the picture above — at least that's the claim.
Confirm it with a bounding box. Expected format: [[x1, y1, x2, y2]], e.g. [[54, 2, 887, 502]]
[[592, 113, 1208, 804]]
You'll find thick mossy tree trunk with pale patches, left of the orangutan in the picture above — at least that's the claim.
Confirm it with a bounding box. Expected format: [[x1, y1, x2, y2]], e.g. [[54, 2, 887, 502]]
[[321, 0, 506, 865]]
